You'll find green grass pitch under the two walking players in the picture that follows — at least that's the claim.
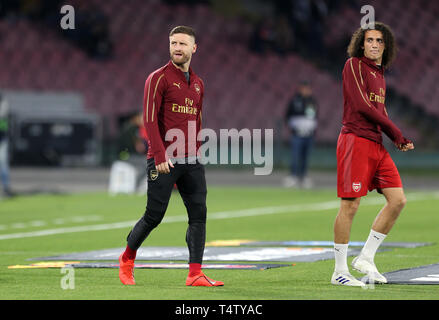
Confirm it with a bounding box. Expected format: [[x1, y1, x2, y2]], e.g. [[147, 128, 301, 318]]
[[0, 186, 439, 300]]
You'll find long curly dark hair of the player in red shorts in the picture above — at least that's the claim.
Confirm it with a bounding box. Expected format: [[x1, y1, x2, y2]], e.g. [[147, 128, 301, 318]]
[[347, 22, 398, 69]]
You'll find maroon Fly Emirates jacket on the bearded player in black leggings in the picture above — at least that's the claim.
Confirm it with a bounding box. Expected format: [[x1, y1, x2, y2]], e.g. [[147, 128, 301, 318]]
[[143, 61, 204, 164]]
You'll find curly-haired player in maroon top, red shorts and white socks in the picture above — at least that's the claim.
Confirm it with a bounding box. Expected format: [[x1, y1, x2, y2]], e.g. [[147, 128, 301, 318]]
[[331, 22, 414, 286]]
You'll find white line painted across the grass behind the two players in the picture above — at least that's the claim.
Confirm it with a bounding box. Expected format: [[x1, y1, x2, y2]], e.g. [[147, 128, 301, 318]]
[[0, 193, 439, 240]]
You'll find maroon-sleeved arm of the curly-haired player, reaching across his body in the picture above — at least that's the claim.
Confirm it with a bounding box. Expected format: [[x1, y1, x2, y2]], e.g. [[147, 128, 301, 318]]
[[343, 58, 411, 148]]
